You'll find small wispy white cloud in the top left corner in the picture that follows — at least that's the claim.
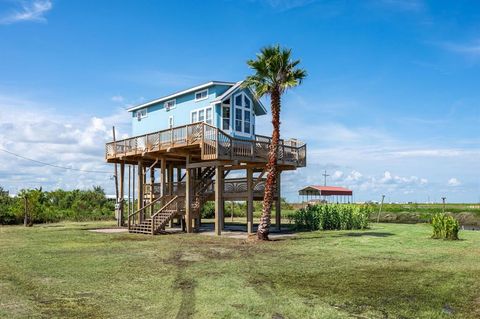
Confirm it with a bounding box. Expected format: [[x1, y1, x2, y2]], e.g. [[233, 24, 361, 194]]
[[0, 0, 53, 24]]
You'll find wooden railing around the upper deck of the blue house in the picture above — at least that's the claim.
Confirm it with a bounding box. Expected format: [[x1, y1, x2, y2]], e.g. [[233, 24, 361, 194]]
[[105, 122, 306, 167]]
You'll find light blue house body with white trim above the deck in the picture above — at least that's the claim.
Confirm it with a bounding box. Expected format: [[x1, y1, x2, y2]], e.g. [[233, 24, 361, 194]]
[[128, 81, 267, 139]]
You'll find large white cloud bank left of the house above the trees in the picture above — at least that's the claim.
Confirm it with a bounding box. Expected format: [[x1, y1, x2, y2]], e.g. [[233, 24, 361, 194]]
[[0, 94, 130, 193]]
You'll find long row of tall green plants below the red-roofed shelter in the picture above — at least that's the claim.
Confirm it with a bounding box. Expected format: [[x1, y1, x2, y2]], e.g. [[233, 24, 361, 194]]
[[293, 204, 372, 230]]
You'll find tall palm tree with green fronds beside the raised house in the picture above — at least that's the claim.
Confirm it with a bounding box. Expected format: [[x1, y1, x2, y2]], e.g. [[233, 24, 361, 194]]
[[242, 45, 307, 240]]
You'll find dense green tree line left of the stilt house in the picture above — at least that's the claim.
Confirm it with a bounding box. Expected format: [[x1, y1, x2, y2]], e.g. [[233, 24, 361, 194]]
[[0, 186, 115, 225]]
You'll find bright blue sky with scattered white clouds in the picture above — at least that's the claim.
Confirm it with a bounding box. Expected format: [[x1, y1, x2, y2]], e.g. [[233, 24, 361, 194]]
[[0, 0, 480, 202]]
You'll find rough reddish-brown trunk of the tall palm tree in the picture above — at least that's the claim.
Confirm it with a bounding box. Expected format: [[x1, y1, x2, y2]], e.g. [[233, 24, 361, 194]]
[[257, 90, 280, 240]]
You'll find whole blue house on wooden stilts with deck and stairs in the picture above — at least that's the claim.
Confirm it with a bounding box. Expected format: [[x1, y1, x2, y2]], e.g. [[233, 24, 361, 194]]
[[105, 81, 306, 234]]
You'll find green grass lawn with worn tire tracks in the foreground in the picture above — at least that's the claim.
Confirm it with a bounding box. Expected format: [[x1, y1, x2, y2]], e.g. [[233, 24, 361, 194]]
[[0, 223, 480, 318]]
